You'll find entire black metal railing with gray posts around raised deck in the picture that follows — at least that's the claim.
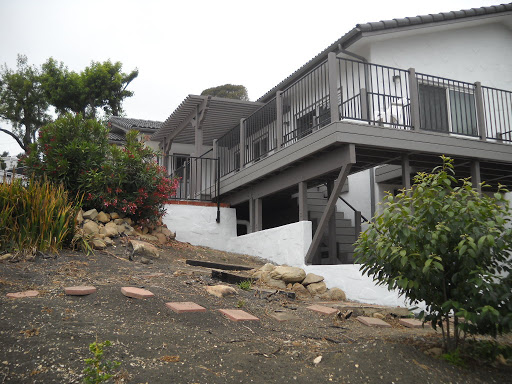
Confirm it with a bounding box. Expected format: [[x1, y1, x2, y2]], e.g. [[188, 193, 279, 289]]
[[217, 54, 512, 176]]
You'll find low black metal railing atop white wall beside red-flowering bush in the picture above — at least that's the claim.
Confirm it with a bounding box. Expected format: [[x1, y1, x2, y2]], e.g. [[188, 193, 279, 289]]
[[170, 155, 220, 201]]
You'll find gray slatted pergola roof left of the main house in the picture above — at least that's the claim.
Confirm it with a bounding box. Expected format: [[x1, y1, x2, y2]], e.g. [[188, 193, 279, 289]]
[[151, 95, 263, 145]]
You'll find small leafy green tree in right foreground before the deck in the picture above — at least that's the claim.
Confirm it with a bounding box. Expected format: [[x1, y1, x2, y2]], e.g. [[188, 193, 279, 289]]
[[356, 157, 512, 350]]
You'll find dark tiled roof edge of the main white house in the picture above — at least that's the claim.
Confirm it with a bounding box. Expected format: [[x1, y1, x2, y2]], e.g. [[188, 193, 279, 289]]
[[258, 3, 512, 102]]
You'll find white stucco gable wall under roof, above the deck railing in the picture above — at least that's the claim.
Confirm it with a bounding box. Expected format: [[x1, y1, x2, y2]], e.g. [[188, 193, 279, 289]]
[[362, 23, 512, 90]]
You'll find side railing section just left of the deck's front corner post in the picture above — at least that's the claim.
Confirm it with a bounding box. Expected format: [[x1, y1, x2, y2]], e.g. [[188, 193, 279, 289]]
[[281, 62, 331, 146]]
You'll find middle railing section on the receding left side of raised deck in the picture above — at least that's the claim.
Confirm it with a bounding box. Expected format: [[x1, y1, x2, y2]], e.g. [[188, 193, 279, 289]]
[[244, 98, 277, 165]]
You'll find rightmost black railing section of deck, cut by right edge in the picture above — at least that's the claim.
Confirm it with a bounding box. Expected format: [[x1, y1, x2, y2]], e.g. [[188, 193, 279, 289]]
[[482, 87, 512, 142]]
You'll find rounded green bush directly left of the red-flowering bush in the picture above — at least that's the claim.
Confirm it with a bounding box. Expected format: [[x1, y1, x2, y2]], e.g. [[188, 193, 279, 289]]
[[24, 113, 109, 194]]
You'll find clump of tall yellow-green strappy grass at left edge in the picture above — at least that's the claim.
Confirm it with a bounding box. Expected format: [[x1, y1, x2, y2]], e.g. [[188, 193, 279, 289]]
[[0, 179, 80, 252]]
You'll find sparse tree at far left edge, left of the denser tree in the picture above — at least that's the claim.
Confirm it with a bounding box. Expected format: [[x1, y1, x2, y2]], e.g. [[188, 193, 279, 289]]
[[0, 55, 51, 151]]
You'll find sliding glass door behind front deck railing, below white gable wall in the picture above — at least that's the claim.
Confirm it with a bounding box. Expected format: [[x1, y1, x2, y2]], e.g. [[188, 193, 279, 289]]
[[419, 84, 478, 136]]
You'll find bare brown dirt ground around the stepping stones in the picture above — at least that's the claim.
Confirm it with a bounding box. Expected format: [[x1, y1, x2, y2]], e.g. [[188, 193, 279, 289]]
[[0, 238, 512, 383]]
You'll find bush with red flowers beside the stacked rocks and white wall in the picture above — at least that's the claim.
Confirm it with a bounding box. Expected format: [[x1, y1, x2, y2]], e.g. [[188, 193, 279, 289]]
[[79, 131, 178, 224]]
